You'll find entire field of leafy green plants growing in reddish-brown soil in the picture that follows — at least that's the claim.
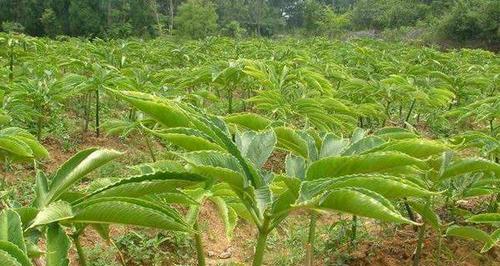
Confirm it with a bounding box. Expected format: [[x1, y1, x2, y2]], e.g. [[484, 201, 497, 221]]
[[0, 33, 500, 266]]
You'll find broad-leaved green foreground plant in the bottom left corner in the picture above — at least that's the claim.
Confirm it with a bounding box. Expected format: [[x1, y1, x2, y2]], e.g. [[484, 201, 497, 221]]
[[0, 145, 205, 265]]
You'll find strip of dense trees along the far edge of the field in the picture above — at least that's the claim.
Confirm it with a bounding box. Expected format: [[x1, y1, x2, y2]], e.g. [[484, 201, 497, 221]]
[[0, 0, 500, 42]]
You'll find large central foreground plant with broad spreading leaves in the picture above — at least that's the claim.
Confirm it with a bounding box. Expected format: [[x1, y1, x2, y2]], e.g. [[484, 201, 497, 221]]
[[113, 91, 450, 265]]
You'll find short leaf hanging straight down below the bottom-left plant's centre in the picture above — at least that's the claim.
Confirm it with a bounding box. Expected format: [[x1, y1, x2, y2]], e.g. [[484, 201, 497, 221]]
[[45, 223, 71, 266]]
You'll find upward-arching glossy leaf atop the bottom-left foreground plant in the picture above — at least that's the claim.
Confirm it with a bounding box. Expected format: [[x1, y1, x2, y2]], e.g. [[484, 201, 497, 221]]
[[45, 148, 121, 204]]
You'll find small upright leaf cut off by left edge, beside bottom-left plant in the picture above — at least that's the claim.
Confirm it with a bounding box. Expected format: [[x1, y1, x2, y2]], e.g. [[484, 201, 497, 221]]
[[0, 209, 26, 252]]
